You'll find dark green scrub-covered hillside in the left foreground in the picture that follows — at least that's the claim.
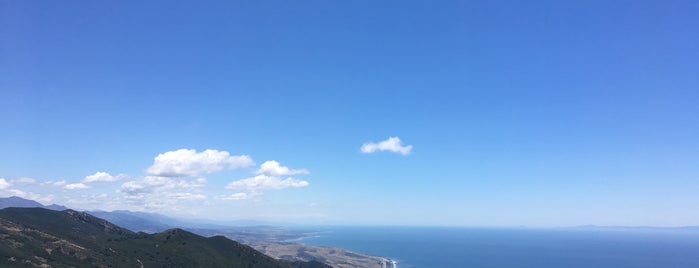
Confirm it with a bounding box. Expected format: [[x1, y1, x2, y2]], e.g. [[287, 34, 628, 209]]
[[0, 207, 330, 268]]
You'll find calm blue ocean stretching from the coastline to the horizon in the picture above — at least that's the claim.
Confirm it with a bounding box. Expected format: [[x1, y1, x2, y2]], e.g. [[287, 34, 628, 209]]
[[299, 227, 699, 268]]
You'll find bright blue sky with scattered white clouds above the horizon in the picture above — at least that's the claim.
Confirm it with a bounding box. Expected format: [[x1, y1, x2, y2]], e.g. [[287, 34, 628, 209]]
[[0, 1, 699, 226]]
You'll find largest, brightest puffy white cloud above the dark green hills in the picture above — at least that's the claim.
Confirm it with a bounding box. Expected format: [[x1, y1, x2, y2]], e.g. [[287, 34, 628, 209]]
[[146, 149, 254, 177]]
